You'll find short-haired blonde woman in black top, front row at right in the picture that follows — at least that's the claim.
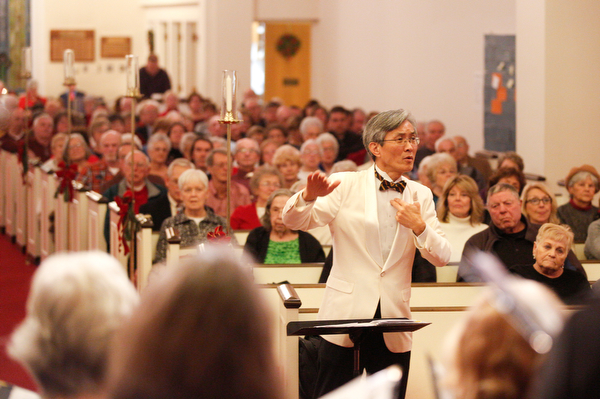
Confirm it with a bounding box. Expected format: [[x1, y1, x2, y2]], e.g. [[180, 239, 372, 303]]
[[510, 223, 591, 305]]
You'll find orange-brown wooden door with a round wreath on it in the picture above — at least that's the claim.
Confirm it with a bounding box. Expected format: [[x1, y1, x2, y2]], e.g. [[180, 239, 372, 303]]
[[264, 22, 311, 107]]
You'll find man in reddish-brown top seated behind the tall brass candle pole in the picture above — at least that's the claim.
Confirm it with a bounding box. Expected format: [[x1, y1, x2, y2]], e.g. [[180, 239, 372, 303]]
[[206, 148, 252, 218]]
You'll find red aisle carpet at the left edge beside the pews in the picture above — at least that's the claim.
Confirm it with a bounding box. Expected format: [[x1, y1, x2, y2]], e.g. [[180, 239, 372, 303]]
[[0, 234, 36, 391]]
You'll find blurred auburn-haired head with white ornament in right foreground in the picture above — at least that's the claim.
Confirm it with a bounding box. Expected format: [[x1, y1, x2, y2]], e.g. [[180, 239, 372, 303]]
[[439, 279, 563, 399]]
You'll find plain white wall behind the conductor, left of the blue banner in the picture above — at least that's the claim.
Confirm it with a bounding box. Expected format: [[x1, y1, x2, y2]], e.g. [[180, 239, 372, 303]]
[[312, 0, 515, 150]]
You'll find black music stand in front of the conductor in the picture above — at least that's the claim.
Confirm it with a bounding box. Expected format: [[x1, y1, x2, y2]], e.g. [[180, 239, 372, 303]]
[[287, 318, 431, 377]]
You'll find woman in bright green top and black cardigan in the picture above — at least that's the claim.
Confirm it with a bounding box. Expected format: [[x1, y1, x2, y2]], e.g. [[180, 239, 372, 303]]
[[244, 189, 325, 264]]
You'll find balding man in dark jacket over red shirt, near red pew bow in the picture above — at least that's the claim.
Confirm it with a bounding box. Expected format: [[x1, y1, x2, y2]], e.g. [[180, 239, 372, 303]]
[[103, 150, 171, 246]]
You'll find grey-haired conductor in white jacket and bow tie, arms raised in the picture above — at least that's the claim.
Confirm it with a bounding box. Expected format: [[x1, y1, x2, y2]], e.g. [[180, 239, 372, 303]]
[[283, 109, 450, 398]]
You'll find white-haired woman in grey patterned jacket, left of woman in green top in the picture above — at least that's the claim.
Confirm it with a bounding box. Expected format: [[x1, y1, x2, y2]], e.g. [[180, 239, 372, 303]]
[[154, 169, 235, 263]]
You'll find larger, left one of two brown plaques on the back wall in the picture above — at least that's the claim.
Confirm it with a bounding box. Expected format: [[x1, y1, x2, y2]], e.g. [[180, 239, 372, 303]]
[[50, 30, 95, 62]]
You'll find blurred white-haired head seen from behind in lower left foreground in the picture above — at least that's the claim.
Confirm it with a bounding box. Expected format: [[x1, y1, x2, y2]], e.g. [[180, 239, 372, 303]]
[[8, 252, 138, 398]]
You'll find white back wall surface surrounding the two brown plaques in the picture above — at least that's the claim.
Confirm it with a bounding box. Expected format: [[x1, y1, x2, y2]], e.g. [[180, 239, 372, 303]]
[[31, 0, 146, 105]]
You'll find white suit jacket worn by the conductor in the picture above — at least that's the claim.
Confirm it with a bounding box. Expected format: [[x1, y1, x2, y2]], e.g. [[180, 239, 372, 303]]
[[283, 166, 451, 352]]
